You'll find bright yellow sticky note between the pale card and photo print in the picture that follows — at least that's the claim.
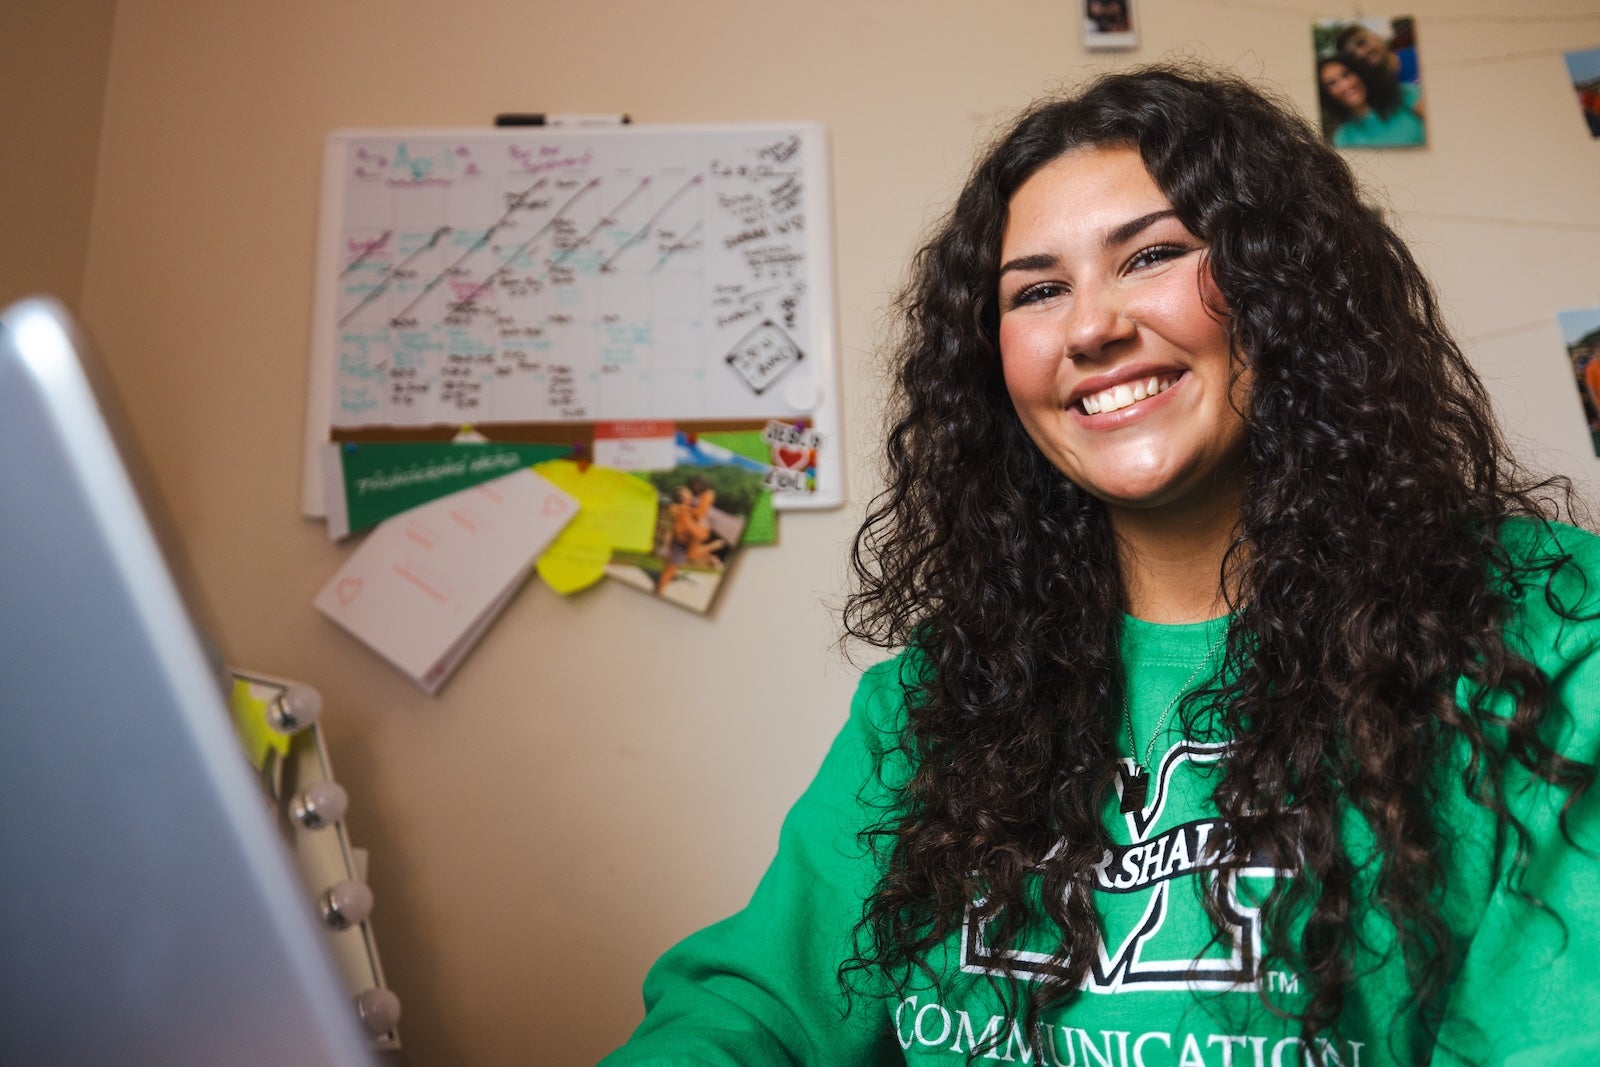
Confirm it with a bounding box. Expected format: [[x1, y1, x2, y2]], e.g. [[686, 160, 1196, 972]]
[[534, 459, 656, 597]]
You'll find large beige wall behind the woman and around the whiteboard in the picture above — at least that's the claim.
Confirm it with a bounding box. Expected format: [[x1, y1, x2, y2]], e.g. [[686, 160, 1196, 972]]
[[56, 0, 1600, 1065]]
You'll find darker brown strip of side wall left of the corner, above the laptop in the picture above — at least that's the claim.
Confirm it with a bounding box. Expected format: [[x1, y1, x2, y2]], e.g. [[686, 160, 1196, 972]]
[[0, 0, 115, 309]]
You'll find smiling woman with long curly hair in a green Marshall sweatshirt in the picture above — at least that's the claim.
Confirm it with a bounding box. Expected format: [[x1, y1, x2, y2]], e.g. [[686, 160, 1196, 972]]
[[610, 69, 1600, 1067]]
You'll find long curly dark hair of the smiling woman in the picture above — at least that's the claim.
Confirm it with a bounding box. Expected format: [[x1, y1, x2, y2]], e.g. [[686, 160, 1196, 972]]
[[842, 67, 1594, 1054]]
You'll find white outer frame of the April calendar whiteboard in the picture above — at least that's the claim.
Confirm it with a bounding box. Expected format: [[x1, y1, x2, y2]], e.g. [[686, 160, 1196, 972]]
[[301, 120, 845, 518]]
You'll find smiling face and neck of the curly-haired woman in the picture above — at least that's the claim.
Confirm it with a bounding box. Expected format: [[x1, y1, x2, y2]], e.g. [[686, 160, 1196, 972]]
[[1000, 147, 1248, 622]]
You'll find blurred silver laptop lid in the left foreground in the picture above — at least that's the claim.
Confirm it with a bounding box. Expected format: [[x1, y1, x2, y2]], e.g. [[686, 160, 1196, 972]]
[[0, 301, 373, 1067]]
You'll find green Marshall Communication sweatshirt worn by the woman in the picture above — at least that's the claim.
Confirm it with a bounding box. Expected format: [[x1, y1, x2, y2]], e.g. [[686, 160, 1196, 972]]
[[603, 523, 1600, 1067]]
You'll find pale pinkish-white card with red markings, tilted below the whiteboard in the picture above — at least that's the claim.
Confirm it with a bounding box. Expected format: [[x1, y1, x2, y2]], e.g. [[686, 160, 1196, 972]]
[[314, 469, 578, 693]]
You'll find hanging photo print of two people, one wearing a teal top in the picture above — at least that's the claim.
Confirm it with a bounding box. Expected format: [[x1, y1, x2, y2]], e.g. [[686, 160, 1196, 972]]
[[1310, 16, 1427, 149]]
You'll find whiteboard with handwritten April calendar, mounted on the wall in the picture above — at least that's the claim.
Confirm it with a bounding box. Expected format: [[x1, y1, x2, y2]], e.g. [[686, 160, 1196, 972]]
[[302, 123, 843, 515]]
